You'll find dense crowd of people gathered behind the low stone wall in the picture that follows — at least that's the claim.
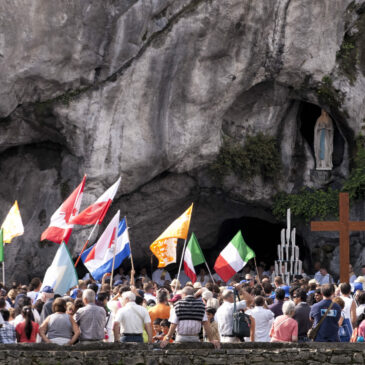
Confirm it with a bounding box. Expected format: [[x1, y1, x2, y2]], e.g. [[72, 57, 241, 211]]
[[0, 263, 365, 348]]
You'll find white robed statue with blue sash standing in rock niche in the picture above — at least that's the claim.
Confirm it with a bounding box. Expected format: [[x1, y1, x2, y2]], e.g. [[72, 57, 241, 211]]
[[314, 109, 333, 170]]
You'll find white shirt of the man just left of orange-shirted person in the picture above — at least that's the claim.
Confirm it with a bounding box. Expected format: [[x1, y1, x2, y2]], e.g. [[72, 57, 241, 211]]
[[114, 302, 151, 334]]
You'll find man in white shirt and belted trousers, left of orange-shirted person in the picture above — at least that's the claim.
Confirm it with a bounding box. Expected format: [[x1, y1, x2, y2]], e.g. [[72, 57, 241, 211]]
[[113, 291, 153, 343]]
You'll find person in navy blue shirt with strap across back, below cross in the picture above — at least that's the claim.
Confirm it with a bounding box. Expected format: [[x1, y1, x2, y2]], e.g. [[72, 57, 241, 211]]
[[309, 284, 341, 342]]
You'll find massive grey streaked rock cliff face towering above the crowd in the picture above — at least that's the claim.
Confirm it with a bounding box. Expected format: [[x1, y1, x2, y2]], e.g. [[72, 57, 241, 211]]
[[0, 0, 365, 280]]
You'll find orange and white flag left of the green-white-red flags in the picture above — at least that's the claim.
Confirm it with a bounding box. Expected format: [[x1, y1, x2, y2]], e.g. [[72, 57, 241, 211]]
[[150, 204, 193, 267]]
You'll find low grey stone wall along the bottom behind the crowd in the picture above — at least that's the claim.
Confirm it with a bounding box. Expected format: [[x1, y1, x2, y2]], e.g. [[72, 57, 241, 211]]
[[0, 343, 365, 365]]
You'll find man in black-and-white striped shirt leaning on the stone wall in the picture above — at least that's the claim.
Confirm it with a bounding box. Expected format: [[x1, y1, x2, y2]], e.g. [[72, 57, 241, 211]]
[[161, 286, 220, 348]]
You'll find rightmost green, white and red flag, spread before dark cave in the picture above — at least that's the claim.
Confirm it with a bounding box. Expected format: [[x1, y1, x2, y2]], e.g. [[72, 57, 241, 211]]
[[214, 231, 256, 282]]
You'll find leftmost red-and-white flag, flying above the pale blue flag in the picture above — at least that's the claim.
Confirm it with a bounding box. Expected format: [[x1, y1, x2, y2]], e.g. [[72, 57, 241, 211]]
[[41, 175, 86, 243]]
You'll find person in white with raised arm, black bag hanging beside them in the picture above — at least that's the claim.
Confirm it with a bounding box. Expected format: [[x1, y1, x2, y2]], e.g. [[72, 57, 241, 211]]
[[215, 289, 249, 342]]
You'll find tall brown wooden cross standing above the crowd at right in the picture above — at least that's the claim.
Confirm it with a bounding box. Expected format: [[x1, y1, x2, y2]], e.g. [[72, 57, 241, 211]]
[[311, 193, 365, 283]]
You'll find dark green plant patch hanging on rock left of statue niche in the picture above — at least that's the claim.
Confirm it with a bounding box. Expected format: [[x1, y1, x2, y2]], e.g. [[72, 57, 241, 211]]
[[211, 133, 281, 180]]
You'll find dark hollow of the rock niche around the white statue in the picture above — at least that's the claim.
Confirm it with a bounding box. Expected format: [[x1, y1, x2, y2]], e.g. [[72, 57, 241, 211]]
[[299, 102, 345, 168]]
